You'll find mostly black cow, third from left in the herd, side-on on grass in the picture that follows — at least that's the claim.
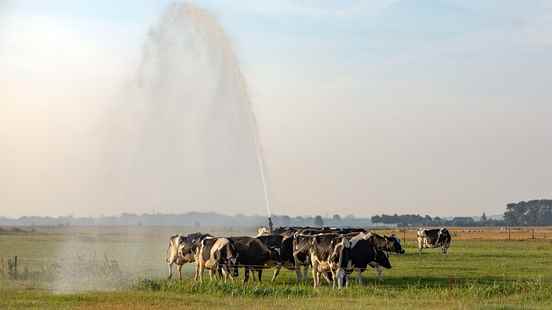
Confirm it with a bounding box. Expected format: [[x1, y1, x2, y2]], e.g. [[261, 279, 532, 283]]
[[228, 237, 280, 283]]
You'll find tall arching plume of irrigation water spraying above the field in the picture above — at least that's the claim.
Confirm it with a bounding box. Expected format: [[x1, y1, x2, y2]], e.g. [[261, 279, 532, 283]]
[[108, 3, 271, 218]]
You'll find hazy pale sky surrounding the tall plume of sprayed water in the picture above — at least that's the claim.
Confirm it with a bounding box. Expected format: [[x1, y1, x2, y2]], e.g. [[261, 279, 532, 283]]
[[0, 0, 552, 216]]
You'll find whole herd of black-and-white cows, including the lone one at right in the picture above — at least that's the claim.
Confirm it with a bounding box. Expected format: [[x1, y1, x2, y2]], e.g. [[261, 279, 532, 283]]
[[166, 227, 451, 288]]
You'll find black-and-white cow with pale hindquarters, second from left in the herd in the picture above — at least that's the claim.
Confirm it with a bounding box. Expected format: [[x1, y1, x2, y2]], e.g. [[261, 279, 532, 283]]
[[194, 237, 238, 282]]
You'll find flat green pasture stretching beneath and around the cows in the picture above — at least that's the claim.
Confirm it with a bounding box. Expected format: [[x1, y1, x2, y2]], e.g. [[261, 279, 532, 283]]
[[0, 227, 552, 310]]
